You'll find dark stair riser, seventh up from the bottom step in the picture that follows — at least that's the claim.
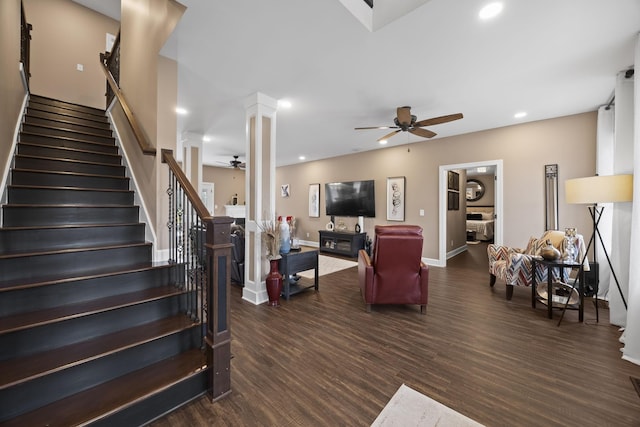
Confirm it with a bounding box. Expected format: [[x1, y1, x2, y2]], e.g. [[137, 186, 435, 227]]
[[3, 205, 138, 227]]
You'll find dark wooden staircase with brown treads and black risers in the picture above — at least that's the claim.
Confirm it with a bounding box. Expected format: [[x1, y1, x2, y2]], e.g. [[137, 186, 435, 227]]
[[0, 95, 210, 426]]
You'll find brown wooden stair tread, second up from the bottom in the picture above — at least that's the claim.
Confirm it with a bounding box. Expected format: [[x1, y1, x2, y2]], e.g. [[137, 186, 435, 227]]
[[0, 314, 199, 390]]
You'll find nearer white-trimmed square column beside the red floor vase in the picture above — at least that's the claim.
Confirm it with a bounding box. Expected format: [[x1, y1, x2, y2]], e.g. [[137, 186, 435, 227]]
[[242, 92, 278, 305]]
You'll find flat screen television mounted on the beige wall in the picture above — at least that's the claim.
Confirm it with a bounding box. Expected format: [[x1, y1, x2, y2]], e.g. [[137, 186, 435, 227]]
[[324, 180, 376, 217]]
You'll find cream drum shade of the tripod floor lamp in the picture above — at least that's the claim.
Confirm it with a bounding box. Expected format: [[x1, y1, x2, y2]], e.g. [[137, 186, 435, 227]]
[[564, 175, 633, 205]]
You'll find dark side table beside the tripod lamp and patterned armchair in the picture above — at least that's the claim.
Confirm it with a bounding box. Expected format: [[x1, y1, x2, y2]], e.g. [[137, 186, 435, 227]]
[[531, 257, 584, 325]]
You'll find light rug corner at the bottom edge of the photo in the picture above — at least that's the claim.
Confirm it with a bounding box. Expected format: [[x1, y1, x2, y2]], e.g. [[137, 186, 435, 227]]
[[371, 384, 482, 427]]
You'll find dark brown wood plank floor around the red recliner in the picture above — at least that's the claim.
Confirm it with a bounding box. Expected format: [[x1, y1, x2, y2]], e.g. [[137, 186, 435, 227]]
[[153, 244, 640, 427]]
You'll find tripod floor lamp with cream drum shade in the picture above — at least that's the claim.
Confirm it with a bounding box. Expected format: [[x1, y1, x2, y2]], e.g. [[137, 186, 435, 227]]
[[565, 175, 633, 321]]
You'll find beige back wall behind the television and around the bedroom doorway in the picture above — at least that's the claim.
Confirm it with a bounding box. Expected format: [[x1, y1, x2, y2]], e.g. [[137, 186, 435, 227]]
[[276, 112, 596, 258]]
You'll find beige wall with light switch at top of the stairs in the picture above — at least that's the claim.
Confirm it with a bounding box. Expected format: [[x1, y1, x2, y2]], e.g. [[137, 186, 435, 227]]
[[23, 0, 119, 109]]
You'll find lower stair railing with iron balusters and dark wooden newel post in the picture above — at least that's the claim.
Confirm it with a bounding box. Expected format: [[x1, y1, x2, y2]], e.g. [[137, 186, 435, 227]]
[[161, 149, 233, 400]]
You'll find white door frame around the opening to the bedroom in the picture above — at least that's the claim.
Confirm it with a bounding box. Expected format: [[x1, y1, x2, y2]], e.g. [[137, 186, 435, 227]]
[[437, 159, 504, 267]]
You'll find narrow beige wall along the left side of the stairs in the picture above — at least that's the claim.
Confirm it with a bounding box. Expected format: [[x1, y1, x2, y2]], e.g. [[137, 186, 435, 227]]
[[0, 0, 29, 189]]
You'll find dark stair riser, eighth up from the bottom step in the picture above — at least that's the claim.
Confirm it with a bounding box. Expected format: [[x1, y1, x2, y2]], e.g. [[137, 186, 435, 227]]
[[7, 187, 133, 206]]
